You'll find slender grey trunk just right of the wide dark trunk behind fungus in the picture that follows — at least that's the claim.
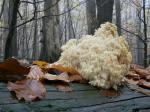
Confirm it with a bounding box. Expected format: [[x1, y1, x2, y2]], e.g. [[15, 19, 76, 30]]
[[115, 0, 121, 35]]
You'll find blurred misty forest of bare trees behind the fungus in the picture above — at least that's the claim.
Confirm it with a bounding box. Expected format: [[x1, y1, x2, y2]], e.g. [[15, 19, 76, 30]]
[[0, 0, 150, 66]]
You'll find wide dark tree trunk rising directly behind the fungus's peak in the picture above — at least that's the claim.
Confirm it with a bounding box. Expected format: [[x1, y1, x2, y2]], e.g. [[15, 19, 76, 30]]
[[96, 0, 114, 27]]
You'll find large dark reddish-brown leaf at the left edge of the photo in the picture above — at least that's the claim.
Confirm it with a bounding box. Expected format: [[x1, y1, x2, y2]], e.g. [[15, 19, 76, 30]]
[[0, 58, 30, 81]]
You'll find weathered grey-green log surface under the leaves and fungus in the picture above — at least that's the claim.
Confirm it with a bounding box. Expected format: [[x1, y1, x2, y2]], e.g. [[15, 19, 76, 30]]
[[0, 83, 150, 112]]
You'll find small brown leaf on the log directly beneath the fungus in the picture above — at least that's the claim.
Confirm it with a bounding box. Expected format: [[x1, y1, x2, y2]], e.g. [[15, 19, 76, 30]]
[[100, 89, 120, 97]]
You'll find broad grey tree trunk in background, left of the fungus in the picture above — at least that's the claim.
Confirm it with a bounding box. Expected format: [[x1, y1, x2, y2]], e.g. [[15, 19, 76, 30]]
[[40, 0, 60, 62]]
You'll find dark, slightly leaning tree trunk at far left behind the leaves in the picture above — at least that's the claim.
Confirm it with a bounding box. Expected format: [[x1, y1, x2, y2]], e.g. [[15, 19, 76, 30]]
[[5, 0, 20, 58]]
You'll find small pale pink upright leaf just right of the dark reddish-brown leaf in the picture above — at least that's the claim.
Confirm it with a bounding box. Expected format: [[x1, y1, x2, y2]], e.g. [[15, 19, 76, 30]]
[[27, 65, 44, 80]]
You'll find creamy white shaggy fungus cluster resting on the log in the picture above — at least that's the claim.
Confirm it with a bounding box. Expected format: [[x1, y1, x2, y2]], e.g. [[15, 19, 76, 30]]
[[56, 22, 132, 89]]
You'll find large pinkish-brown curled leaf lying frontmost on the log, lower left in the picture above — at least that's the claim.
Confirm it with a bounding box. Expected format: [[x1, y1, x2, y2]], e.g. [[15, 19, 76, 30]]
[[7, 80, 46, 101]]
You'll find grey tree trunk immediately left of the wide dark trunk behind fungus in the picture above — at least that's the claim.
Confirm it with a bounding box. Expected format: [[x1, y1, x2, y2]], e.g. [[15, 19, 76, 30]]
[[86, 0, 96, 34]]
